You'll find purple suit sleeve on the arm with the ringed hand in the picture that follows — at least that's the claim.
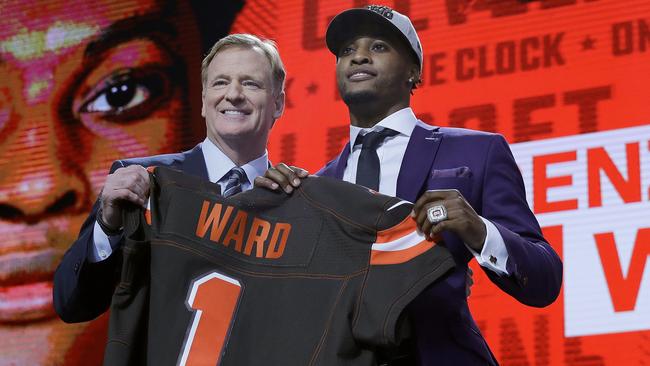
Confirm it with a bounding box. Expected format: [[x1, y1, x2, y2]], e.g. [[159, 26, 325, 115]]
[[481, 135, 562, 307]]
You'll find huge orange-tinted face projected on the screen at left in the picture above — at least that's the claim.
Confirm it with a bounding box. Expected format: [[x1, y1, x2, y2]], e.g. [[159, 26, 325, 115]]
[[0, 0, 204, 365]]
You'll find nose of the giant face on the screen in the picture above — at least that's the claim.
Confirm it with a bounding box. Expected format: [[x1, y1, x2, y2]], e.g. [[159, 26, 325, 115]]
[[0, 105, 91, 223]]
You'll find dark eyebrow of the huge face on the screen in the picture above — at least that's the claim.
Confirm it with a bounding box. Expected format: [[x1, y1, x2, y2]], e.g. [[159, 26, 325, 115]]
[[84, 13, 178, 59]]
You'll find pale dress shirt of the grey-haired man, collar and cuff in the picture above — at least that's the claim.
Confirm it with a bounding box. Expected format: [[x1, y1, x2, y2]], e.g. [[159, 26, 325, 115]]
[[88, 137, 269, 263]]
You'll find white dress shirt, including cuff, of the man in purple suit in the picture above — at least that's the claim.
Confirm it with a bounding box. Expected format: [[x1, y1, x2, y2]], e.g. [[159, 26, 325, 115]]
[[343, 108, 508, 275]]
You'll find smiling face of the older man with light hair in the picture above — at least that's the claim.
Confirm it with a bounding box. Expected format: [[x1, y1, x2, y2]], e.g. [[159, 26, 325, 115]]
[[201, 46, 284, 163]]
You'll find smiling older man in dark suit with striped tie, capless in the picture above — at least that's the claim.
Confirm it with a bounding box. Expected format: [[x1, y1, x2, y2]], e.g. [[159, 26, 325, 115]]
[[54, 34, 285, 322]]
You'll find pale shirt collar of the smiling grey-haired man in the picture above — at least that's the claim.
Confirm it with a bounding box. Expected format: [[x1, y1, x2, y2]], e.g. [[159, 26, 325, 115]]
[[201, 137, 269, 183]]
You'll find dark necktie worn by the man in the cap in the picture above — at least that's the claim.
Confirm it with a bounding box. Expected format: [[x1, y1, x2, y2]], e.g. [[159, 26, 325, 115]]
[[355, 128, 398, 191]]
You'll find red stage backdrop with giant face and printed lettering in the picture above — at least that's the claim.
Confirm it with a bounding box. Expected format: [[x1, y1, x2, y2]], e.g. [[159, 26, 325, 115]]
[[0, 0, 650, 366]]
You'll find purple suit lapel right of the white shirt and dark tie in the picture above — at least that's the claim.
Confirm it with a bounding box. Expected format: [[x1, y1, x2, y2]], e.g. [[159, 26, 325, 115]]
[[397, 126, 442, 202]]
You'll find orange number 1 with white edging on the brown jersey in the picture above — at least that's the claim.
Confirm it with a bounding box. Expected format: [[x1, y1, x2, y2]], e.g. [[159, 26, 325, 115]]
[[178, 272, 241, 366]]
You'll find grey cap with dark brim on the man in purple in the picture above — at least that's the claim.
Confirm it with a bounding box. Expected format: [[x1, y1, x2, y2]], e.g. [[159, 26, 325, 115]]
[[325, 5, 422, 71]]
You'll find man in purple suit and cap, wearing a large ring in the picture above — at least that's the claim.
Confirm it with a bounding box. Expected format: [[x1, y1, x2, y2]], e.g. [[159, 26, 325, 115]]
[[256, 6, 562, 365]]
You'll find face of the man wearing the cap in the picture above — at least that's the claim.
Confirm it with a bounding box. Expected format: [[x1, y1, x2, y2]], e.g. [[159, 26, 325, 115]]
[[336, 34, 419, 113]]
